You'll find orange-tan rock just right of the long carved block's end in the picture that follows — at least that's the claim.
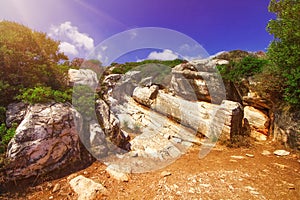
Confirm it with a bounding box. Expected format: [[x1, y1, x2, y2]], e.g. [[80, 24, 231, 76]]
[[244, 106, 270, 141]]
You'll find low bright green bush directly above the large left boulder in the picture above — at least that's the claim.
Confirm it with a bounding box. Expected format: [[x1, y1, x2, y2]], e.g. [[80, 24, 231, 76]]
[[16, 86, 72, 104]]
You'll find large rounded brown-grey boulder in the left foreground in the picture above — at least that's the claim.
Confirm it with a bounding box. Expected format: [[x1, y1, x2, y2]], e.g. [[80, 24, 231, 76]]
[[7, 103, 88, 179]]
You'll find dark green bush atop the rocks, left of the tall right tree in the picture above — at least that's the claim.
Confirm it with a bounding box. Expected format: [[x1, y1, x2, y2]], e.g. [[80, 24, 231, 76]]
[[217, 56, 268, 82]]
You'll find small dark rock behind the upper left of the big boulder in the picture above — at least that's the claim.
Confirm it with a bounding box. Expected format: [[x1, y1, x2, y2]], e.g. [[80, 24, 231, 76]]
[[6, 102, 28, 127]]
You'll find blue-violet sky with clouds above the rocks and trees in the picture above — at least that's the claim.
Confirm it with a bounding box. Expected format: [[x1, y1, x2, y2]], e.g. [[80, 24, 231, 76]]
[[0, 0, 274, 61]]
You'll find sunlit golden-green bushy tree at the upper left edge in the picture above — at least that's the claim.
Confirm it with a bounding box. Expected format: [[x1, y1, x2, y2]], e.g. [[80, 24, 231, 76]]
[[0, 21, 67, 106]]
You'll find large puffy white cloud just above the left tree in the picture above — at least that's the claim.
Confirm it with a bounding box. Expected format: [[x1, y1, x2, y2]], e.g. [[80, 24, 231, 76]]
[[49, 21, 94, 55]]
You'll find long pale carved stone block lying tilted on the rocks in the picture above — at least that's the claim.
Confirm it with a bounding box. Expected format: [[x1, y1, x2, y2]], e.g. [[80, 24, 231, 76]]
[[134, 87, 243, 139]]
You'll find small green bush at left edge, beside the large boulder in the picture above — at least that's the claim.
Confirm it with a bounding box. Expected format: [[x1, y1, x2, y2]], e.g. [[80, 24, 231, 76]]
[[0, 123, 18, 154]]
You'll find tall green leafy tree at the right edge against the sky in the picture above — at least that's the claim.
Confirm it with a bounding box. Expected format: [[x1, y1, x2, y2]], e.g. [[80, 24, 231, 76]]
[[267, 0, 300, 105]]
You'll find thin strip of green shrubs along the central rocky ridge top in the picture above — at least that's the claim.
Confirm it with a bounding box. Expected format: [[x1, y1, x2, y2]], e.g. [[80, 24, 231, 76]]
[[111, 59, 185, 74]]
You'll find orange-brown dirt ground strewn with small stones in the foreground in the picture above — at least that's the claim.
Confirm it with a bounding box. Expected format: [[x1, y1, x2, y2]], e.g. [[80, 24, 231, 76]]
[[0, 142, 300, 200]]
